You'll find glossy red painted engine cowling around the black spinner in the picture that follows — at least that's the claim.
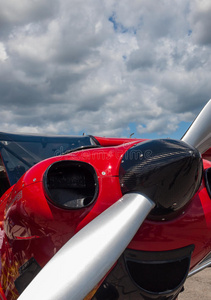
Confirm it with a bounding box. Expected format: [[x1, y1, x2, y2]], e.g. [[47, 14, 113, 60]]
[[0, 138, 211, 300]]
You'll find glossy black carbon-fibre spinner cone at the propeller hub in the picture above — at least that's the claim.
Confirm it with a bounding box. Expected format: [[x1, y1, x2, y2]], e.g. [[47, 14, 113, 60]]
[[119, 139, 203, 219]]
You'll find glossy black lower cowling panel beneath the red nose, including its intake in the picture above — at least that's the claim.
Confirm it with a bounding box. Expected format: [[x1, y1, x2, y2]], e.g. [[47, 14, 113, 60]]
[[92, 245, 194, 300]]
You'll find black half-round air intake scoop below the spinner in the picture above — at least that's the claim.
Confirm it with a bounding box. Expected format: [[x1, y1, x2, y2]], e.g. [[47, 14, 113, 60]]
[[124, 245, 194, 299]]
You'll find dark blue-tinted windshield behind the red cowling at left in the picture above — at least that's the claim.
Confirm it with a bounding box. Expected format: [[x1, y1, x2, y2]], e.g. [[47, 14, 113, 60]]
[[0, 133, 96, 185]]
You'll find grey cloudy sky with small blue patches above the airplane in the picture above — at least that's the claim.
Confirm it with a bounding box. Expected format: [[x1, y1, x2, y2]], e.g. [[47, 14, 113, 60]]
[[0, 0, 211, 138]]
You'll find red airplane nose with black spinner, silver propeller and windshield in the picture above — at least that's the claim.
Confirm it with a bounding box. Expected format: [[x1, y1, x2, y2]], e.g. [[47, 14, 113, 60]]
[[0, 101, 211, 300]]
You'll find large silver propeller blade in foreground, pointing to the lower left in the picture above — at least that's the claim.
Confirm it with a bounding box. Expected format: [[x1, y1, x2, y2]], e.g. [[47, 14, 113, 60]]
[[18, 193, 155, 300]]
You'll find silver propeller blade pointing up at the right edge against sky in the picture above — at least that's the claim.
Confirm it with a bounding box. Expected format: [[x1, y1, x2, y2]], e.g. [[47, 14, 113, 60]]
[[182, 100, 211, 154]]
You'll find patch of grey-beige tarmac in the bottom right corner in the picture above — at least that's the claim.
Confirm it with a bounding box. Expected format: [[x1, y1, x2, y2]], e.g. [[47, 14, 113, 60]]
[[178, 267, 211, 300]]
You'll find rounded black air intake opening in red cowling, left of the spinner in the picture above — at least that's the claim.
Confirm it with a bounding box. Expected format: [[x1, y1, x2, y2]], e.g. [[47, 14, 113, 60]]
[[44, 161, 98, 209]]
